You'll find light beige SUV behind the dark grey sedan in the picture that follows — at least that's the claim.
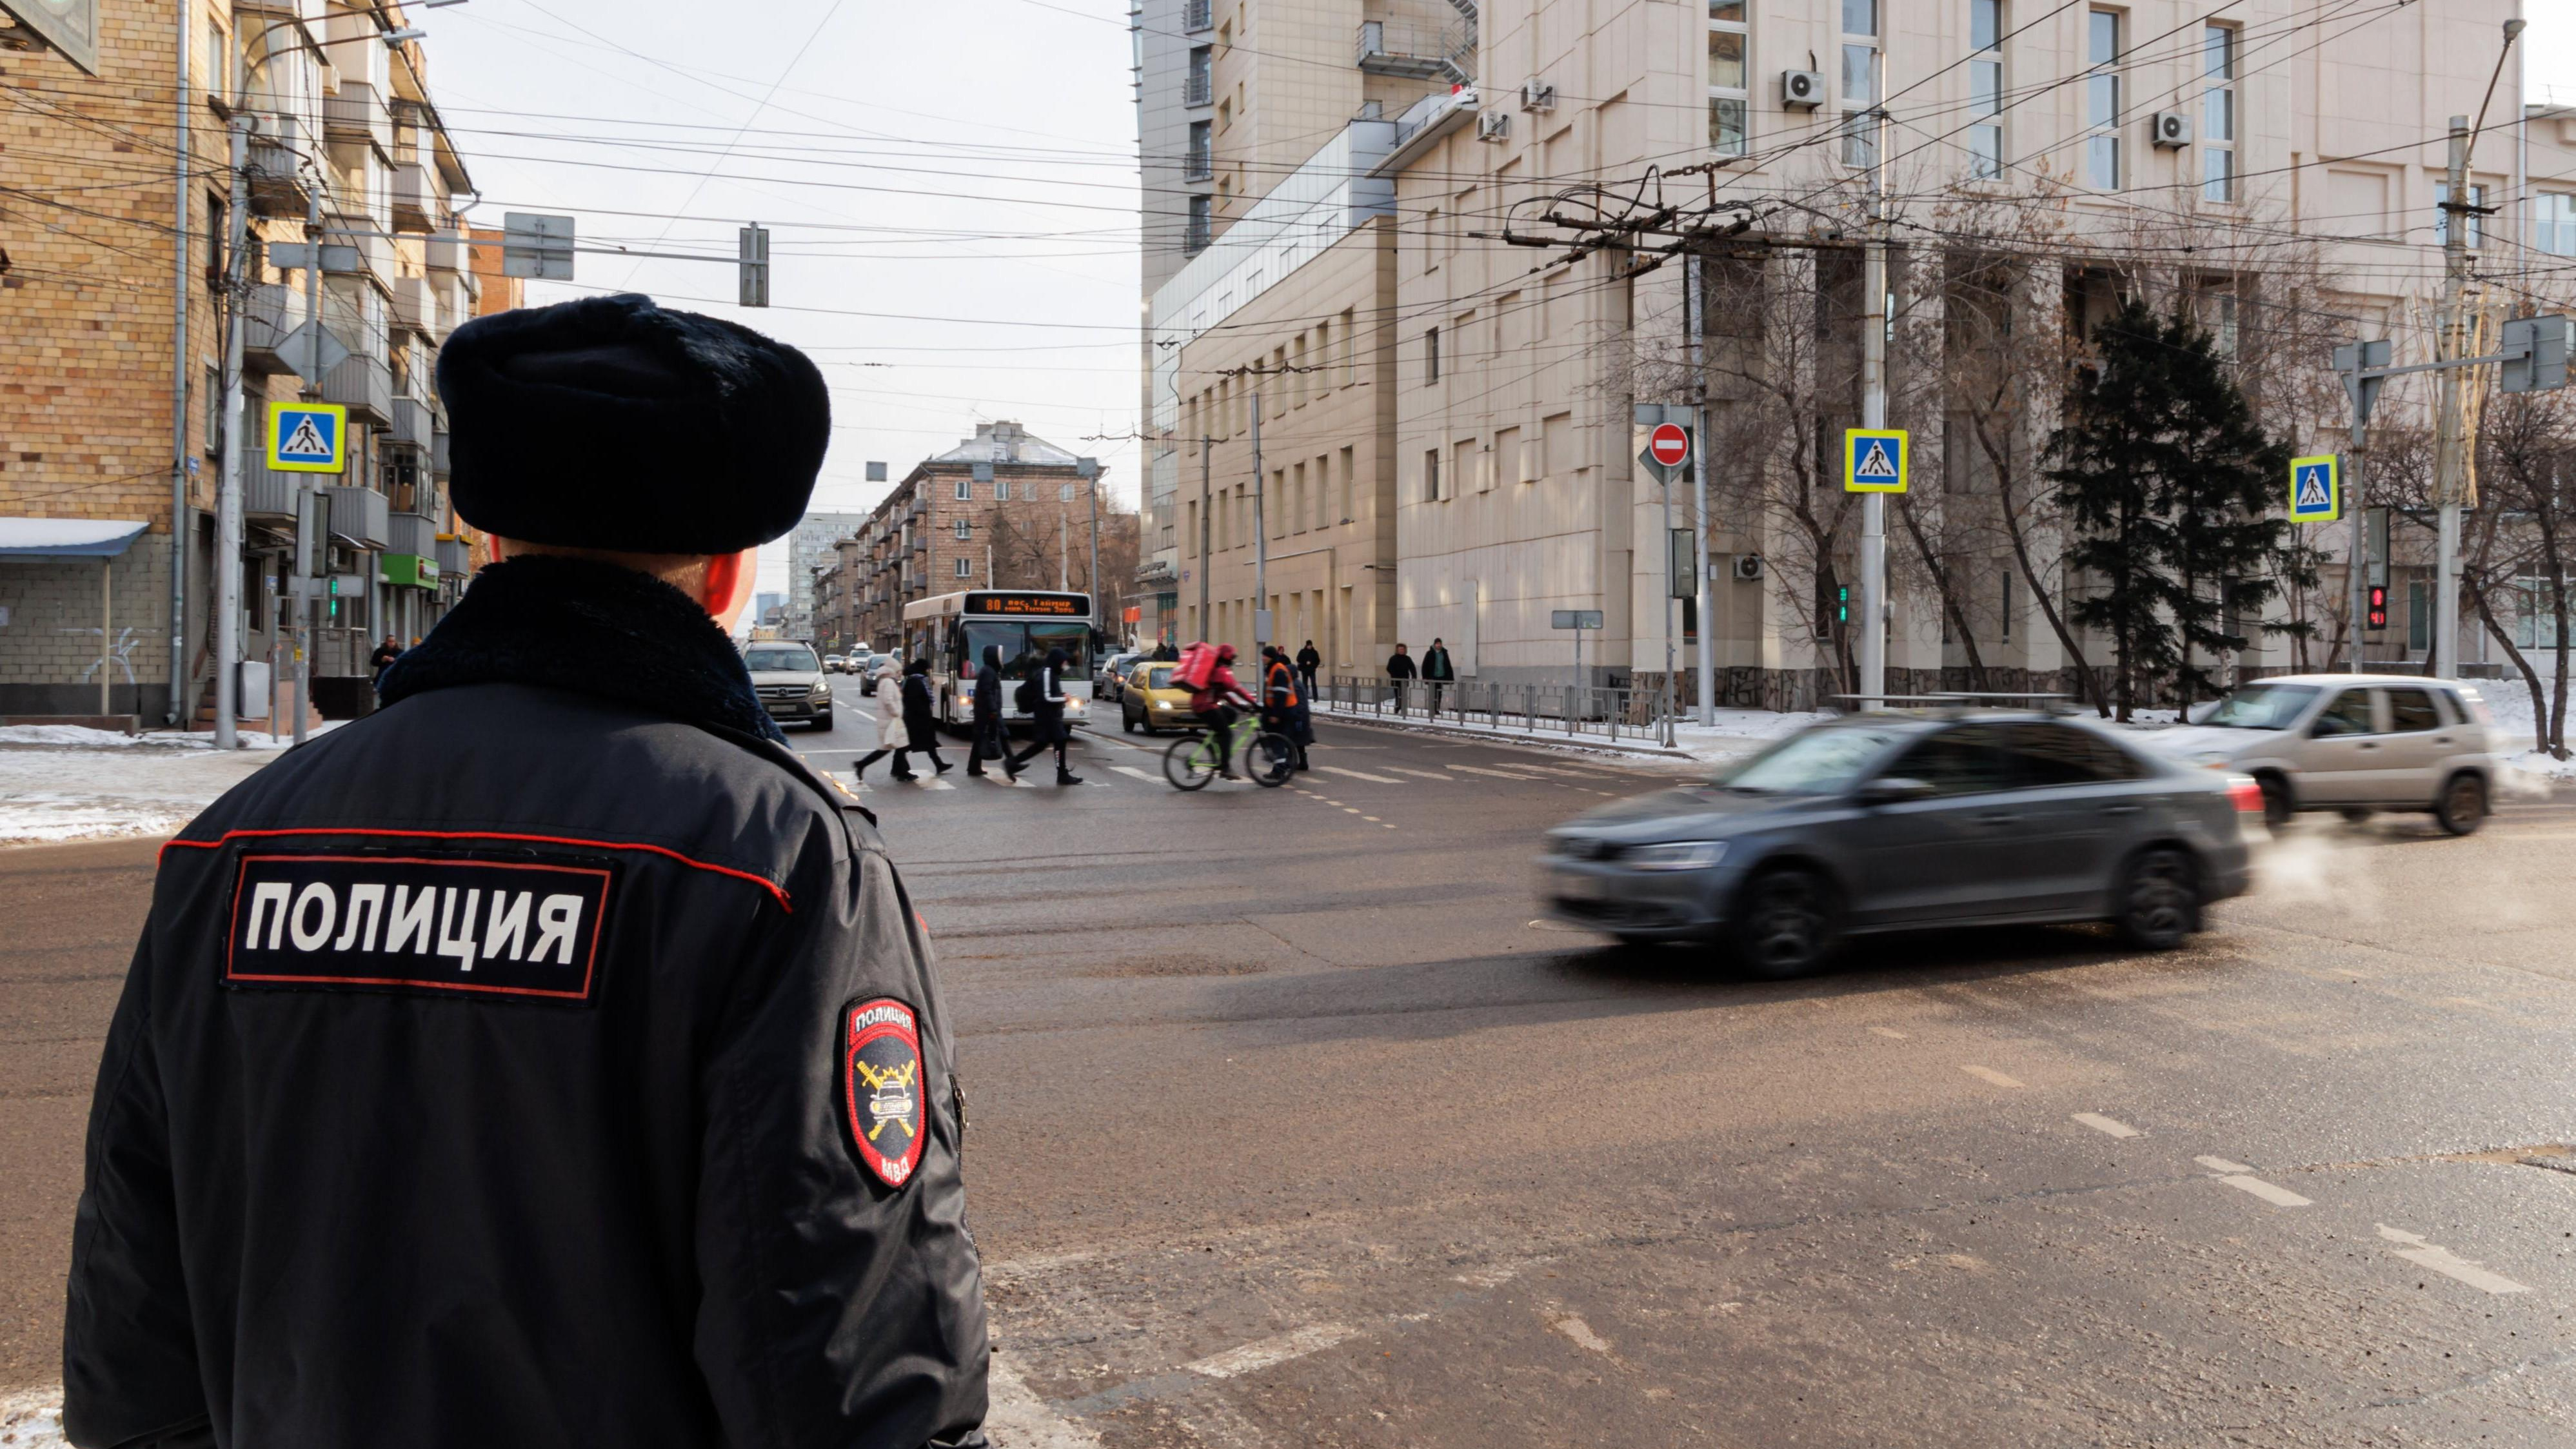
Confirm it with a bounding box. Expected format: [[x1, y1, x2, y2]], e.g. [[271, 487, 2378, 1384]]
[[2146, 675, 2499, 834]]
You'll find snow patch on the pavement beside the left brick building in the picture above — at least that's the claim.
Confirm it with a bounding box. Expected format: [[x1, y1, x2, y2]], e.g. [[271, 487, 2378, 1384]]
[[0, 725, 330, 849]]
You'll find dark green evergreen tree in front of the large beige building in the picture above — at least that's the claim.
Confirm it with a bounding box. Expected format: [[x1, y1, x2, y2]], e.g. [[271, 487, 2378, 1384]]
[[2048, 299, 2298, 721]]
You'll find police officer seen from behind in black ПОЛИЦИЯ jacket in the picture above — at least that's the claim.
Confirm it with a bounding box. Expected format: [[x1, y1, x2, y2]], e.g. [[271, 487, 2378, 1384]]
[[64, 296, 987, 1449]]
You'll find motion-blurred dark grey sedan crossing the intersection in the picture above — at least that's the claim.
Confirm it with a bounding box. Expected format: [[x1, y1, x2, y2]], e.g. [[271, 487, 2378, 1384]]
[[1540, 711, 2262, 978]]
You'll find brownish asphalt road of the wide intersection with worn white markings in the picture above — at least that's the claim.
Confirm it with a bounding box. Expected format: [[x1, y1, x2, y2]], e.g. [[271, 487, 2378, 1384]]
[[0, 680, 2576, 1449]]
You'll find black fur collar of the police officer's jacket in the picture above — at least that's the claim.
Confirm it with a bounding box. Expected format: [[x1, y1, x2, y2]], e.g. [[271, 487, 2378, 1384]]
[[379, 553, 786, 744]]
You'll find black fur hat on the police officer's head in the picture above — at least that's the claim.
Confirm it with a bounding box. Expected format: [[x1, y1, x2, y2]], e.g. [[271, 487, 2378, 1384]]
[[438, 293, 832, 553]]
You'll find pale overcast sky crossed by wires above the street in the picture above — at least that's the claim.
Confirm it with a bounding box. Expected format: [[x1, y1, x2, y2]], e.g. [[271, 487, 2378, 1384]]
[[415, 0, 2576, 589]]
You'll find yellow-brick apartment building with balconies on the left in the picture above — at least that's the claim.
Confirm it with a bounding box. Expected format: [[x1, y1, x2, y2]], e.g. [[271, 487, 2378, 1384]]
[[0, 0, 491, 725]]
